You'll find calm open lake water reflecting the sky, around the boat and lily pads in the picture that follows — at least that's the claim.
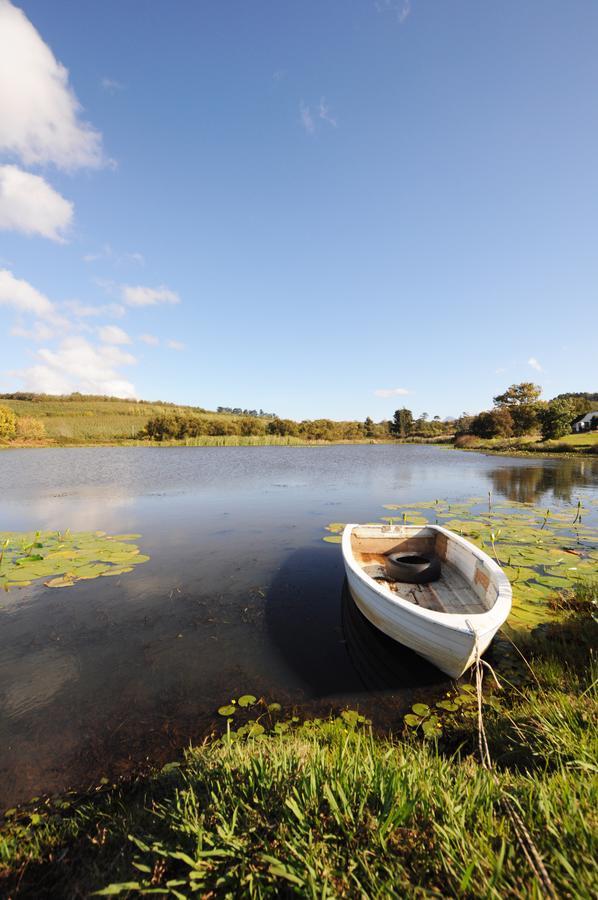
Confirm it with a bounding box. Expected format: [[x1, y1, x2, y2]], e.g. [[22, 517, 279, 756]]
[[0, 445, 598, 806]]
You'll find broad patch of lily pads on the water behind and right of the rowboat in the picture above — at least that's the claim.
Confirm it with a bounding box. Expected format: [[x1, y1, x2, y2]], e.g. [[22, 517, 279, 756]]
[[324, 495, 598, 629]]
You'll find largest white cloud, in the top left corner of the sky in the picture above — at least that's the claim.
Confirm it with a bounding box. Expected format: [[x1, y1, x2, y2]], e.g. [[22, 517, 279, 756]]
[[0, 0, 104, 170]]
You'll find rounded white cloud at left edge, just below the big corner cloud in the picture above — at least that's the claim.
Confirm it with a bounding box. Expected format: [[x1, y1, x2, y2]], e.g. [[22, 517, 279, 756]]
[[0, 165, 73, 243]]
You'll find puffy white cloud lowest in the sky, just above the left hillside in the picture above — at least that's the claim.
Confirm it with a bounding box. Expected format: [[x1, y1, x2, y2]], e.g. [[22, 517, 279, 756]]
[[11, 337, 137, 397]]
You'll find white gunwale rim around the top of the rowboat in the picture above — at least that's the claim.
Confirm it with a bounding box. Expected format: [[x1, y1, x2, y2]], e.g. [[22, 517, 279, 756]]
[[342, 523, 513, 639]]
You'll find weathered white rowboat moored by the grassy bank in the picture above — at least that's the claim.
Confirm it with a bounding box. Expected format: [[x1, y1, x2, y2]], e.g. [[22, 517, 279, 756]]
[[342, 525, 512, 678]]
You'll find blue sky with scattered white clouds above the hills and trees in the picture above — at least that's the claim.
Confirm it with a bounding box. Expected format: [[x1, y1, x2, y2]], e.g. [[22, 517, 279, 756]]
[[0, 0, 598, 419]]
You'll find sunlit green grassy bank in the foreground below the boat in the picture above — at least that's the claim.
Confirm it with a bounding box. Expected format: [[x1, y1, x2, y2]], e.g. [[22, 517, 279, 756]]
[[0, 591, 598, 898]]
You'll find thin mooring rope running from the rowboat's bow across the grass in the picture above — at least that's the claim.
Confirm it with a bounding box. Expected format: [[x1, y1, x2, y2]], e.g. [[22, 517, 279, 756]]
[[465, 619, 558, 900]]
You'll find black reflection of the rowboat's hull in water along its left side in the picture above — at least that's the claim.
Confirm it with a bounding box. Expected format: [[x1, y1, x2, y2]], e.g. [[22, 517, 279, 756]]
[[341, 579, 448, 691]]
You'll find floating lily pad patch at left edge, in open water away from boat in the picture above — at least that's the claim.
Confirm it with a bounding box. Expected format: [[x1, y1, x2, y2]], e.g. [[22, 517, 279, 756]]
[[0, 530, 149, 591]]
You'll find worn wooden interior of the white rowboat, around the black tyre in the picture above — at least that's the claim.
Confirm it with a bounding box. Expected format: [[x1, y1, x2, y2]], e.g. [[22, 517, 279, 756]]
[[351, 526, 497, 615]]
